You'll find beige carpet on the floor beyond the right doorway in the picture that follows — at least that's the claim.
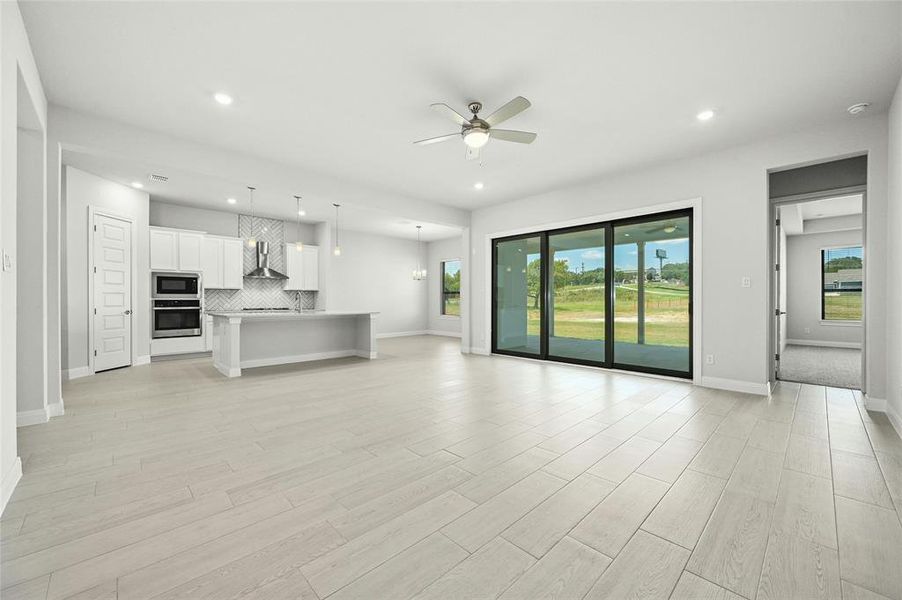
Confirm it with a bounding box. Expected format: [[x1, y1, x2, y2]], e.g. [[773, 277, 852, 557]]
[[780, 345, 861, 390]]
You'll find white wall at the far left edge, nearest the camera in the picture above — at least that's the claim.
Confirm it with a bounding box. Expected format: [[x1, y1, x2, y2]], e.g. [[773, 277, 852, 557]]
[[0, 2, 47, 510]]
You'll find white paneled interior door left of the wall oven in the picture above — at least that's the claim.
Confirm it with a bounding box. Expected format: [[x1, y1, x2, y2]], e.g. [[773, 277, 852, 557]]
[[93, 215, 132, 372]]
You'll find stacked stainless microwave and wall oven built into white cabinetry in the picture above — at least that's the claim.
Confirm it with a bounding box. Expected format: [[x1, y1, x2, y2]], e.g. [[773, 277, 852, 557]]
[[151, 272, 204, 339]]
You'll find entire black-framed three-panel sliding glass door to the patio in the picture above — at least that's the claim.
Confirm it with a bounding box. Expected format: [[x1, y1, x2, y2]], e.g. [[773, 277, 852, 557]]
[[492, 210, 692, 377]]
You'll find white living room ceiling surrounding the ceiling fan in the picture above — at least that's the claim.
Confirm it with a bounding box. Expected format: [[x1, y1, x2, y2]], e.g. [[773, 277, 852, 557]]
[[21, 1, 902, 214]]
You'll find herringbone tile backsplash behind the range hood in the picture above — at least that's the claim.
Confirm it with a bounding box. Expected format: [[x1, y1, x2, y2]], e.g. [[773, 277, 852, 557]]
[[204, 215, 316, 310]]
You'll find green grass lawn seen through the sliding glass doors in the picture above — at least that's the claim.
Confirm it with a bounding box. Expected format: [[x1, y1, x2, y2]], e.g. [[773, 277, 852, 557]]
[[527, 283, 690, 347]]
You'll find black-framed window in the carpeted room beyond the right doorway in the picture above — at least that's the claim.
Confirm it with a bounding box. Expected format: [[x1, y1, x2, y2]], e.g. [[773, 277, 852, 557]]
[[821, 246, 864, 321]]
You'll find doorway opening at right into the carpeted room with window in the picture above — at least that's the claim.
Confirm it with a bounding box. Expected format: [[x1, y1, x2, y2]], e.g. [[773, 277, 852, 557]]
[[774, 192, 865, 389]]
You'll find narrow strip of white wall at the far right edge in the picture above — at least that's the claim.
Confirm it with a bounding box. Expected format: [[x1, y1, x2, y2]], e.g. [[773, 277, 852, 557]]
[[888, 72, 902, 424]]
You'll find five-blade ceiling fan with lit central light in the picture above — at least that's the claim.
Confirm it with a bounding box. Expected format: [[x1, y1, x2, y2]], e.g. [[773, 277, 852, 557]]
[[414, 96, 536, 160]]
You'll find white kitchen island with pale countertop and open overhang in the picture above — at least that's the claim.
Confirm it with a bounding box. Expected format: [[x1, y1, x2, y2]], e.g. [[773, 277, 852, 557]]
[[207, 310, 378, 377]]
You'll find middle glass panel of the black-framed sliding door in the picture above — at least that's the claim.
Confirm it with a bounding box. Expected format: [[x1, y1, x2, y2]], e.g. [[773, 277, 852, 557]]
[[547, 226, 607, 364]]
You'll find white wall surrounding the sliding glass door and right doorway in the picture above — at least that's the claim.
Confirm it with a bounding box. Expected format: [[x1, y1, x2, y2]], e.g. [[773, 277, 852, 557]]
[[470, 115, 887, 397]]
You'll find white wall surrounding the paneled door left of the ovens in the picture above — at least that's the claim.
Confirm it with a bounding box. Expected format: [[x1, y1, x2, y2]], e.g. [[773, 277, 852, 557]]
[[63, 167, 150, 377]]
